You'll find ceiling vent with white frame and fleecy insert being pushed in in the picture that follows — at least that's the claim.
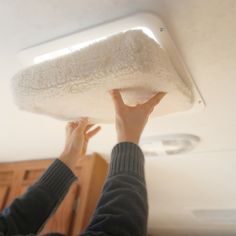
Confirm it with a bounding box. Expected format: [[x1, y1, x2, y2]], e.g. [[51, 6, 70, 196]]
[[12, 13, 203, 122]]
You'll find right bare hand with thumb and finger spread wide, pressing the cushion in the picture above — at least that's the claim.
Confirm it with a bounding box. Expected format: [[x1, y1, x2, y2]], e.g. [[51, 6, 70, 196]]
[[109, 89, 166, 144]]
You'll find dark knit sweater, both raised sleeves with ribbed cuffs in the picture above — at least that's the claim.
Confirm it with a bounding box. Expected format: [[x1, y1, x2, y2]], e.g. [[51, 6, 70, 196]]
[[0, 142, 148, 236]]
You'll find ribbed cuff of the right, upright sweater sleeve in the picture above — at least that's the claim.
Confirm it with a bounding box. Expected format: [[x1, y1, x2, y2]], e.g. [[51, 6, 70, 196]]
[[108, 142, 144, 178]]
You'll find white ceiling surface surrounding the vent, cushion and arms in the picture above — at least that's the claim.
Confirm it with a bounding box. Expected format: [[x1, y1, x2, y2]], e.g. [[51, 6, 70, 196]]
[[0, 0, 236, 236]]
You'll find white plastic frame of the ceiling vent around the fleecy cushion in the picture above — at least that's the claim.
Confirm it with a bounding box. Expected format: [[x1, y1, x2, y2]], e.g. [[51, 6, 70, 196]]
[[18, 12, 205, 110]]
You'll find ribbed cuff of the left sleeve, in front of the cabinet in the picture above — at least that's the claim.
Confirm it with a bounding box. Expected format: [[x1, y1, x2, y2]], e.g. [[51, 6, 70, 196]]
[[37, 159, 76, 198]]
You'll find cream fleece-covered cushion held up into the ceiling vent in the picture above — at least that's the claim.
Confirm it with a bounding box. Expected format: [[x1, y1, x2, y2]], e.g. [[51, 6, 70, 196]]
[[12, 30, 193, 122]]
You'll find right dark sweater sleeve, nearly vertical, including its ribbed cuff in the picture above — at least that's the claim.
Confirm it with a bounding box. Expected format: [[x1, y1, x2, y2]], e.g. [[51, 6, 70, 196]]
[[81, 142, 148, 236]]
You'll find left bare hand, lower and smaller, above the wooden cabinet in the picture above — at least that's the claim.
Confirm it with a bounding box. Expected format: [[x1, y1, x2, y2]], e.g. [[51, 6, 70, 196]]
[[60, 118, 101, 169]]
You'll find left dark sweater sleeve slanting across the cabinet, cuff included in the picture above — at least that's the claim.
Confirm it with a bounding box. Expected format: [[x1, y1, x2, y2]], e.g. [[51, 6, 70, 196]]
[[0, 159, 76, 236]]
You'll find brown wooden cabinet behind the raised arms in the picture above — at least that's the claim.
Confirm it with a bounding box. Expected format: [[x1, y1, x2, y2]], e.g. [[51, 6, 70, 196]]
[[0, 153, 108, 236]]
